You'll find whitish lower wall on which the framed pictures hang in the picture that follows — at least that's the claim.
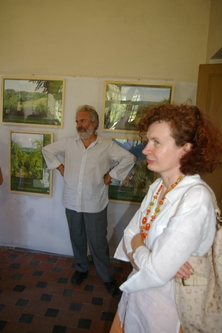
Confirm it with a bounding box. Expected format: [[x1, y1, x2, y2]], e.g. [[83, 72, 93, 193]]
[[0, 77, 196, 255]]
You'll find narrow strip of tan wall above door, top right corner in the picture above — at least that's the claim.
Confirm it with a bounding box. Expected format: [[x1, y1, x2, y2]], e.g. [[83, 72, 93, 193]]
[[206, 0, 222, 63]]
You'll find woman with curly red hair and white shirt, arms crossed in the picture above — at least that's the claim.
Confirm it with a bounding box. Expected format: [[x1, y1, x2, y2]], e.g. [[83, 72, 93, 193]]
[[111, 104, 222, 333]]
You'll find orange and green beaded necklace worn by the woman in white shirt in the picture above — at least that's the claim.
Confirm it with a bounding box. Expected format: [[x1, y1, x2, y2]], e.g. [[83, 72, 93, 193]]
[[140, 176, 184, 241]]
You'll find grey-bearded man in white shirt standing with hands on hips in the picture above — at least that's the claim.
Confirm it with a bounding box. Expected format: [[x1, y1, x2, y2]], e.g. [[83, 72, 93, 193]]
[[42, 105, 135, 295]]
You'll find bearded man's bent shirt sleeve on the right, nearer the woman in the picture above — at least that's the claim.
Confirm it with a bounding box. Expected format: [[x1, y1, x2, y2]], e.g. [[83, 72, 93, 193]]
[[109, 142, 136, 180]]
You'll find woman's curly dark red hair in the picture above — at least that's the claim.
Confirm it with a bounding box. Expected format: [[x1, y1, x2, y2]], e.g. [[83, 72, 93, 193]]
[[138, 104, 222, 175]]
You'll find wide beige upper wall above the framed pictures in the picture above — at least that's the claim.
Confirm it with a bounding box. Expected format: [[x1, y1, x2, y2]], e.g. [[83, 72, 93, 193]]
[[0, 0, 211, 82]]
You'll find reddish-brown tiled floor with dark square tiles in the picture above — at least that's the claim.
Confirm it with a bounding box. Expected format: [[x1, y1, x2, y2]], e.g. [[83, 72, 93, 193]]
[[0, 247, 131, 333]]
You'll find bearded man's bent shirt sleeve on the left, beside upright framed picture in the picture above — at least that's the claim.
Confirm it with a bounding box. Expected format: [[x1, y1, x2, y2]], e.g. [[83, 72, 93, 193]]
[[42, 139, 65, 170]]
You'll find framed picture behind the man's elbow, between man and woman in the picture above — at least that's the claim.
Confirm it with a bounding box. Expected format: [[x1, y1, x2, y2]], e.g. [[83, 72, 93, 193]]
[[109, 138, 156, 204]]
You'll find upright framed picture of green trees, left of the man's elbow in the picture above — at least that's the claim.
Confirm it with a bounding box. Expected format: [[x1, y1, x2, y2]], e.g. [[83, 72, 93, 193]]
[[9, 131, 53, 196]]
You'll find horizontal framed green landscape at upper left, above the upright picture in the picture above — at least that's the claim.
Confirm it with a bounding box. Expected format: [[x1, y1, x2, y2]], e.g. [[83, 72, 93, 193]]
[[2, 77, 65, 127]]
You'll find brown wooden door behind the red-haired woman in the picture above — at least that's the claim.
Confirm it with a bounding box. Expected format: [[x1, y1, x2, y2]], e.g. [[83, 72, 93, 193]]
[[196, 64, 222, 210]]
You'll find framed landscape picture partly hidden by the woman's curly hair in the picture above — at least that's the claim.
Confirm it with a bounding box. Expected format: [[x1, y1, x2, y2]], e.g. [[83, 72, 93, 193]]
[[103, 81, 174, 133]]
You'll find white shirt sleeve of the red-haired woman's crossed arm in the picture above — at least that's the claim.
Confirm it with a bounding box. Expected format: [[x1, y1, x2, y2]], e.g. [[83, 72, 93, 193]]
[[121, 188, 216, 292]]
